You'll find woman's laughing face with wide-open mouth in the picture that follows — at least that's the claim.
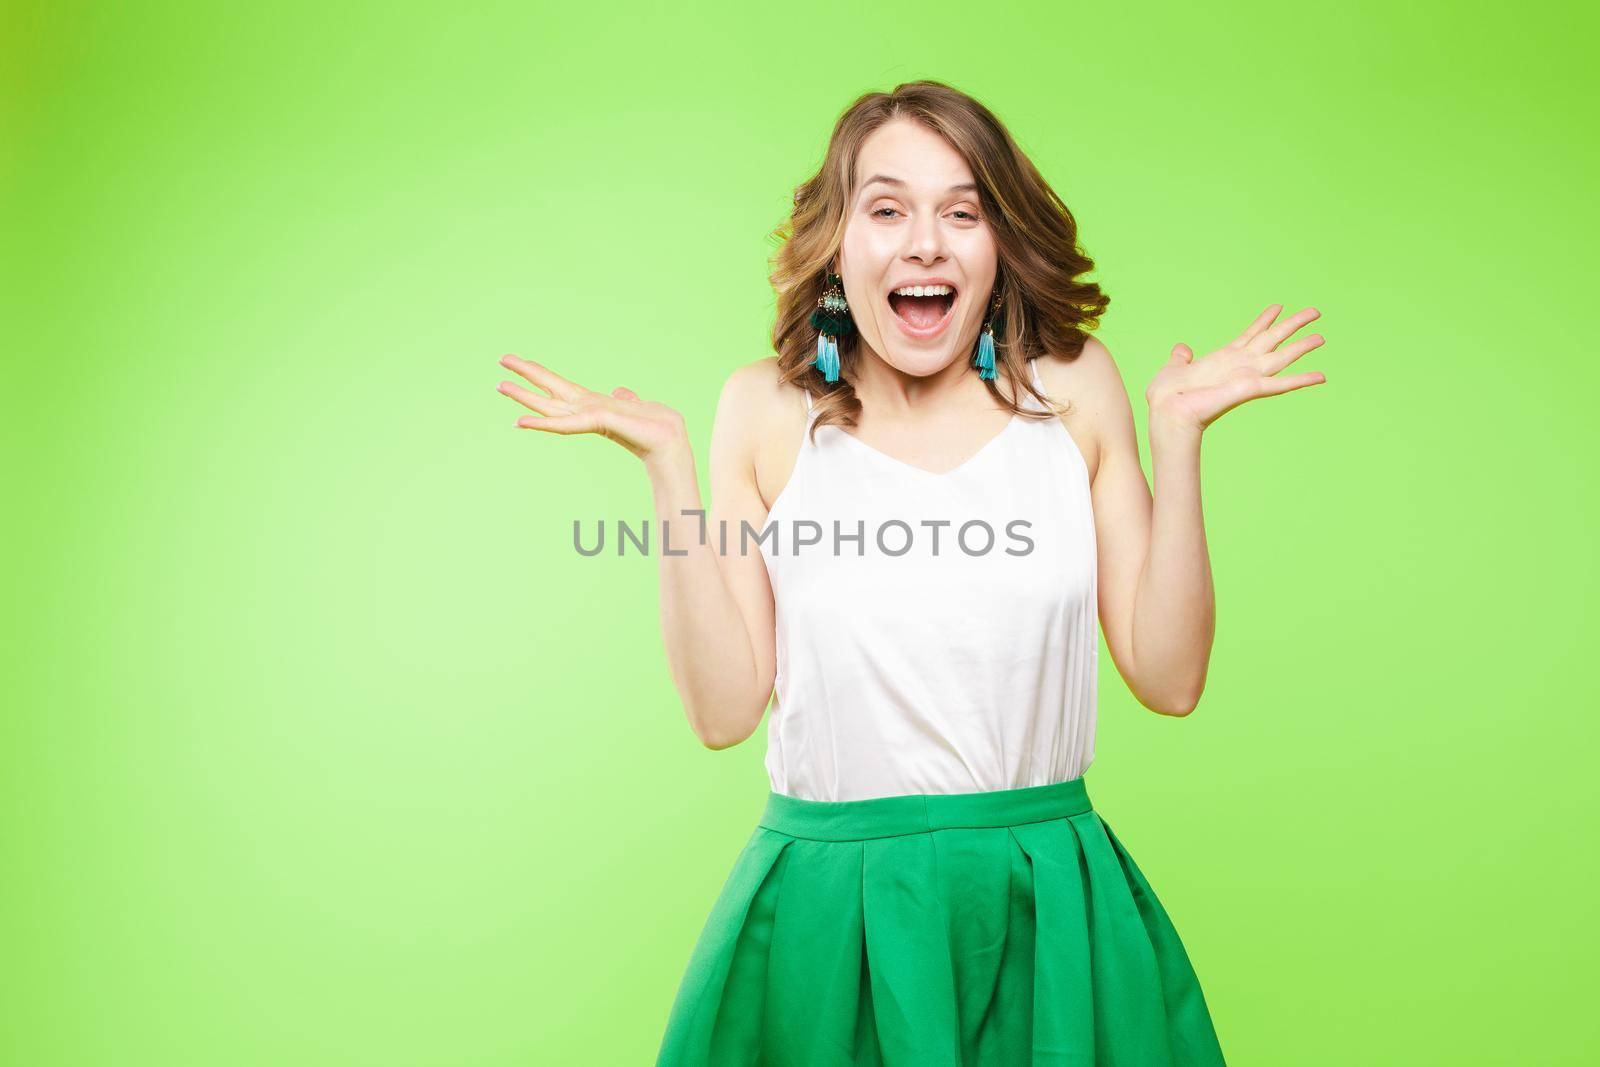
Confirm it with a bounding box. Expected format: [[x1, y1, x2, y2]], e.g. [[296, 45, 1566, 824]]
[[838, 118, 998, 376]]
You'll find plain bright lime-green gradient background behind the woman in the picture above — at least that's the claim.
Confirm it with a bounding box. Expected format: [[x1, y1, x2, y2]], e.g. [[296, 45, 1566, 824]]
[[0, 3, 1600, 1067]]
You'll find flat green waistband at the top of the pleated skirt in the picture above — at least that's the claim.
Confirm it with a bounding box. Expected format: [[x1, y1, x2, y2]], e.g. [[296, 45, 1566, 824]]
[[760, 777, 1093, 841]]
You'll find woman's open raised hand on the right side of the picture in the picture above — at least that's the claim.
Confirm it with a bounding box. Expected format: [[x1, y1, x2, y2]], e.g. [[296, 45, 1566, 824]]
[[1144, 304, 1328, 432]]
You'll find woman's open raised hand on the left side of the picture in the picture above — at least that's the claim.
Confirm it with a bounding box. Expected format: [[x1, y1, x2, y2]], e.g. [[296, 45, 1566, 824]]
[[498, 355, 688, 462]]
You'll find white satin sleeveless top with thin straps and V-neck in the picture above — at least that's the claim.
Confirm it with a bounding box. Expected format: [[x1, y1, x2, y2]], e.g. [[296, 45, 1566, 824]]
[[752, 365, 1099, 800]]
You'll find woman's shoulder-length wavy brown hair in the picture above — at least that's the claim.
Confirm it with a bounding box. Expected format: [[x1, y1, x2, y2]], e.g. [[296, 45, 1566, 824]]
[[768, 80, 1110, 434]]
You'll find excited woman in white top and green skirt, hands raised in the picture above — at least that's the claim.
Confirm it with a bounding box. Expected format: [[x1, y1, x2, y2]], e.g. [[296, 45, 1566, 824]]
[[501, 82, 1323, 1067]]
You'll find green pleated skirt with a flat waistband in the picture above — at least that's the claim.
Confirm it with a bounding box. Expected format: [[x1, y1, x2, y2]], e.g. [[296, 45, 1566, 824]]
[[656, 777, 1224, 1067]]
